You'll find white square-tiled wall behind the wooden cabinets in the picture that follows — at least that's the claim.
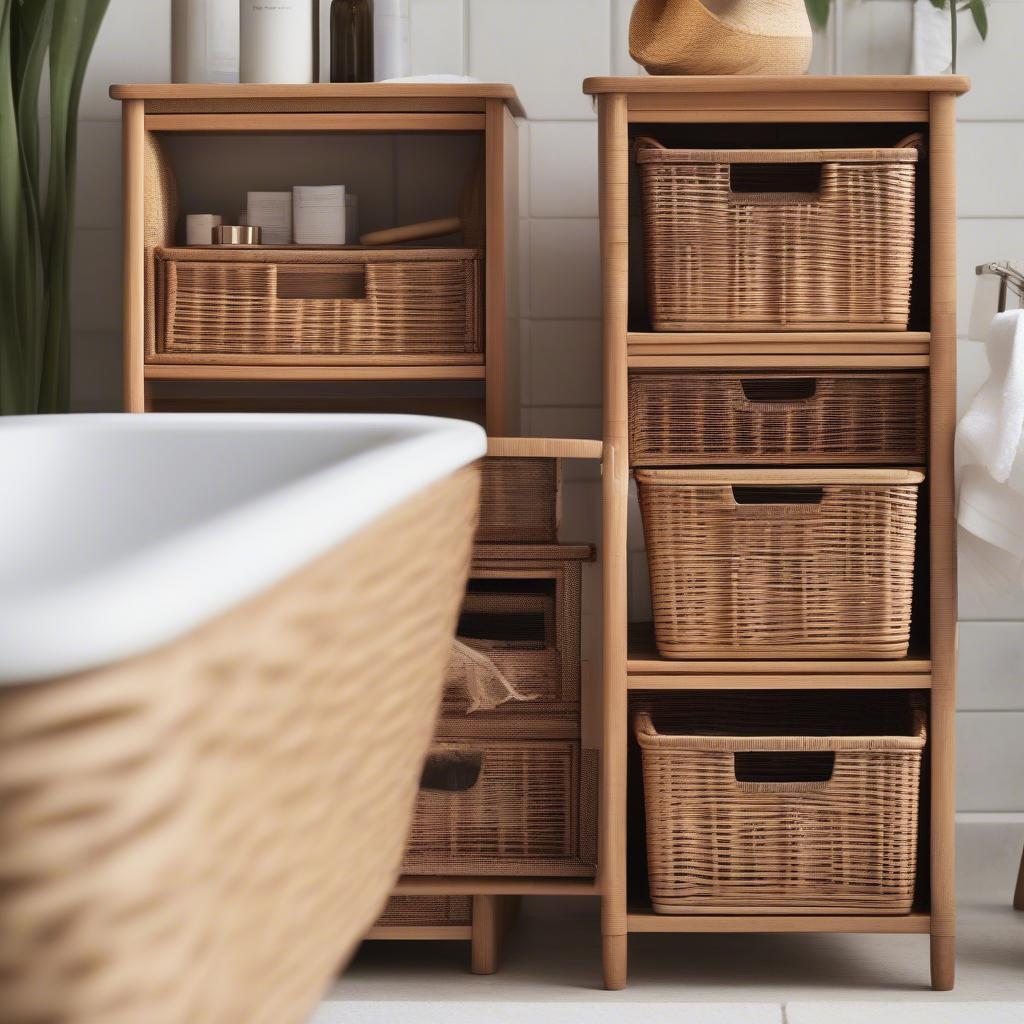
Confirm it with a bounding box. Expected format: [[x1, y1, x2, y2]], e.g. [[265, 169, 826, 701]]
[[73, 0, 1024, 810]]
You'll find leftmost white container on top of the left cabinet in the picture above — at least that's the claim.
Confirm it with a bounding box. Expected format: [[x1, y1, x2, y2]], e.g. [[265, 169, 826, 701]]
[[171, 0, 239, 82]]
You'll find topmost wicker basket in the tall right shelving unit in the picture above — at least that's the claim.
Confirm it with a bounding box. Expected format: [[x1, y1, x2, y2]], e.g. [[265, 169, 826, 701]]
[[637, 137, 918, 331]]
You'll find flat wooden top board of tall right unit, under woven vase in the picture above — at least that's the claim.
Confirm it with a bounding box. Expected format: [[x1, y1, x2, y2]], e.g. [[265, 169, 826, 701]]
[[583, 75, 971, 95]]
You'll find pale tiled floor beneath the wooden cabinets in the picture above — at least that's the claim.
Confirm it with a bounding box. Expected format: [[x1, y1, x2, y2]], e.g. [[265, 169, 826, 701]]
[[313, 815, 1024, 1024]]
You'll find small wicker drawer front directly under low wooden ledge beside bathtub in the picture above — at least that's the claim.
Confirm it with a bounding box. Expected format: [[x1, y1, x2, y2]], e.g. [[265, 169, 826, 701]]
[[476, 457, 559, 544]]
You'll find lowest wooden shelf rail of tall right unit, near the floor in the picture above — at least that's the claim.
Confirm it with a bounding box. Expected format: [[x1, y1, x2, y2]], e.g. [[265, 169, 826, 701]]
[[626, 909, 931, 935]]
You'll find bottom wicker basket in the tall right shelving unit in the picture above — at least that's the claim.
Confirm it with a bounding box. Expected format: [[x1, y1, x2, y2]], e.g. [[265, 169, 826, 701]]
[[634, 692, 925, 914]]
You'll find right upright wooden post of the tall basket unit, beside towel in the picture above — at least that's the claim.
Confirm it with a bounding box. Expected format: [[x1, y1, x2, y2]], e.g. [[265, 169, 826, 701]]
[[928, 92, 956, 991]]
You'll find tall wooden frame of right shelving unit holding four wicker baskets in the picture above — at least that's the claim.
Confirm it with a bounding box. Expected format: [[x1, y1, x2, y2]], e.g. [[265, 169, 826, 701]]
[[584, 76, 968, 990]]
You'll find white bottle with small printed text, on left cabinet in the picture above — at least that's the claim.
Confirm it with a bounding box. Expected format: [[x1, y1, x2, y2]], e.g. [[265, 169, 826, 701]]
[[239, 0, 313, 83]]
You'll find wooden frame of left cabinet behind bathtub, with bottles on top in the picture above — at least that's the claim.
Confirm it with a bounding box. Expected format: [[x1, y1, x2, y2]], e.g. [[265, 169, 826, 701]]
[[111, 83, 523, 435]]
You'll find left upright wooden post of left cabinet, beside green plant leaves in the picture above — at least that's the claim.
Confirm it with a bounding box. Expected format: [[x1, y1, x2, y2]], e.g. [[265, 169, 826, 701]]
[[121, 99, 145, 413]]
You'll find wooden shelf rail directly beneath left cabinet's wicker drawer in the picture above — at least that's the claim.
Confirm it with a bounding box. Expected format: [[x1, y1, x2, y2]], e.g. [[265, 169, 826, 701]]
[[144, 362, 486, 381]]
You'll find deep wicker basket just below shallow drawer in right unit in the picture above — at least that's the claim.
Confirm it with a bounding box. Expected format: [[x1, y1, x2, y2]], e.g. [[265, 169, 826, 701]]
[[636, 469, 924, 657]]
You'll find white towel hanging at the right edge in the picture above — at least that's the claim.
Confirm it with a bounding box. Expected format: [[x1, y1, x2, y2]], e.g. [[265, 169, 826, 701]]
[[956, 309, 1024, 582]]
